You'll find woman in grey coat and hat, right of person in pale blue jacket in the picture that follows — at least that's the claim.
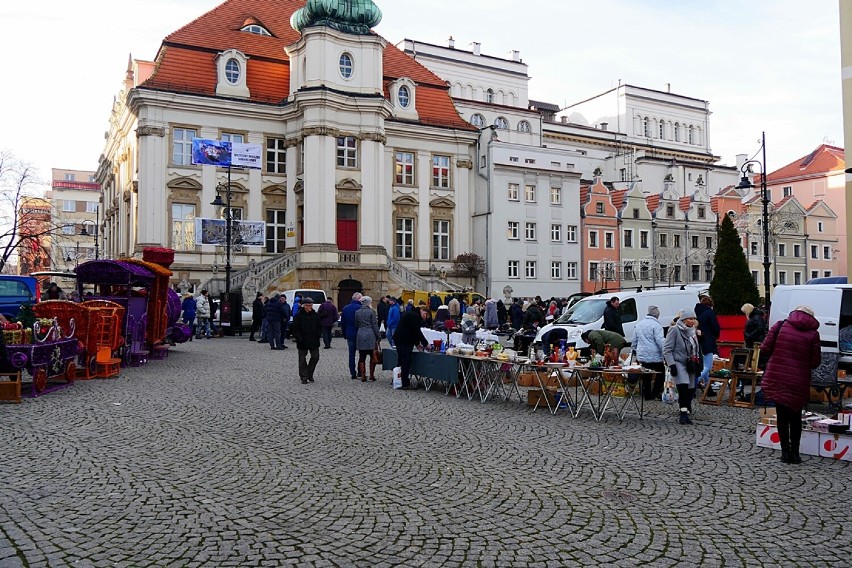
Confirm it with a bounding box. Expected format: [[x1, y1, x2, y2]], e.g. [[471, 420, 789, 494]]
[[663, 308, 703, 424]]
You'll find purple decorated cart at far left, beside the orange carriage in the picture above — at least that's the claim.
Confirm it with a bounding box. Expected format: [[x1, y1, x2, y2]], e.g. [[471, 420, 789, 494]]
[[6, 319, 79, 397]]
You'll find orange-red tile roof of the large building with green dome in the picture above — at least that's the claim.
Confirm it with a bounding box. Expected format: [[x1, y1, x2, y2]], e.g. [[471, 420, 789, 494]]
[[141, 0, 476, 130]]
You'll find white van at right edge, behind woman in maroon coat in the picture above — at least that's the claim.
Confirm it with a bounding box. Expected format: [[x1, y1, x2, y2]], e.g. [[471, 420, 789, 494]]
[[769, 284, 852, 367]]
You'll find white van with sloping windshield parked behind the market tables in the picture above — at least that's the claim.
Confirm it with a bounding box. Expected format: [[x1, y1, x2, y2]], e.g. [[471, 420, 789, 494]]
[[535, 286, 707, 349]]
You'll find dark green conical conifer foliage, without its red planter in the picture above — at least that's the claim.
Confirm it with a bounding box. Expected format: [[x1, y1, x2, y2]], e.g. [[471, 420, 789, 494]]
[[710, 215, 760, 316]]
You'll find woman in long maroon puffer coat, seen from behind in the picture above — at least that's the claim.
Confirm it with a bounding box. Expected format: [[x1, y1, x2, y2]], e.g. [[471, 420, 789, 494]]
[[760, 306, 822, 463]]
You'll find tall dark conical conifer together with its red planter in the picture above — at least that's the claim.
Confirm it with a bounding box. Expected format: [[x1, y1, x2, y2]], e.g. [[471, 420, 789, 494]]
[[710, 215, 760, 357]]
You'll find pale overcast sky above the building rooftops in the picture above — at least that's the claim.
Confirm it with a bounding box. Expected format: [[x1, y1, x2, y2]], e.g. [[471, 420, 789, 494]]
[[0, 0, 843, 189]]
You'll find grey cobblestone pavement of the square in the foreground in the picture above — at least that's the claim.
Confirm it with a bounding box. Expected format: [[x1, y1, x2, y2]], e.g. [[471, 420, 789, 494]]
[[0, 337, 852, 568]]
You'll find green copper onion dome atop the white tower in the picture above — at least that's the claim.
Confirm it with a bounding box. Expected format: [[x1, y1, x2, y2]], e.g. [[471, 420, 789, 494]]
[[290, 0, 382, 35]]
